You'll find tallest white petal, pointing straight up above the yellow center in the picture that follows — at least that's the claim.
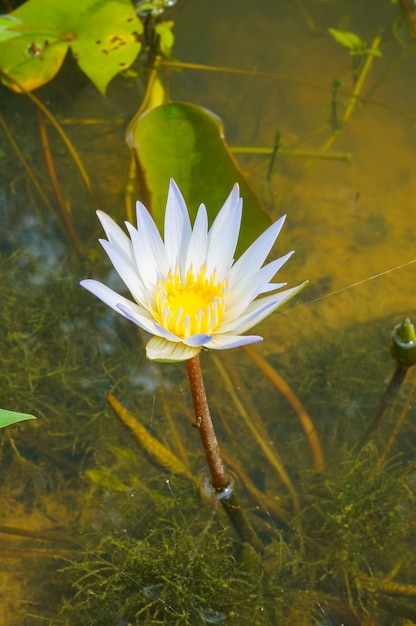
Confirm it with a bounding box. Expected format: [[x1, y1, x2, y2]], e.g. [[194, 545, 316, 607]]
[[164, 179, 192, 271]]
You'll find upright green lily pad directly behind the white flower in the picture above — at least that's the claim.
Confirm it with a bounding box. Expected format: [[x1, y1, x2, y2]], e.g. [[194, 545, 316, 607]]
[[127, 102, 271, 253]]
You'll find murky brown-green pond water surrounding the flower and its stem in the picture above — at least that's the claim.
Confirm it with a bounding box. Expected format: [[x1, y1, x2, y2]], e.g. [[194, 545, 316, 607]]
[[0, 0, 416, 626]]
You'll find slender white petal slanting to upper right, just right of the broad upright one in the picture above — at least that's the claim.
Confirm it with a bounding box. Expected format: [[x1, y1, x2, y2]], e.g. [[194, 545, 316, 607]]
[[230, 215, 287, 285]]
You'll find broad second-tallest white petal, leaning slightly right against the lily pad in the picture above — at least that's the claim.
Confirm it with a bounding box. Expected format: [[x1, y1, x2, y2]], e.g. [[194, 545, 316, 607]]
[[207, 185, 243, 281]]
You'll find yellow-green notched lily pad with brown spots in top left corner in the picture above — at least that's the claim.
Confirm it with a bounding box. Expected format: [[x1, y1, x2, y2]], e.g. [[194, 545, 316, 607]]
[[0, 0, 143, 94]]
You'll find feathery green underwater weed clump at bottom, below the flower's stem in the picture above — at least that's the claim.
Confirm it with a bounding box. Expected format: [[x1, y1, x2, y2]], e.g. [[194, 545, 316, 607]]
[[54, 481, 314, 626]]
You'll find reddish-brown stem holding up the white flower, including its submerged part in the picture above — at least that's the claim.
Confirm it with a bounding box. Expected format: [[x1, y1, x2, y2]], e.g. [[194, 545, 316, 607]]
[[186, 354, 264, 552]]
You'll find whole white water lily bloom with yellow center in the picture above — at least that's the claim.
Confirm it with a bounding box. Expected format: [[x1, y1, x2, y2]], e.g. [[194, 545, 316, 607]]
[[81, 180, 306, 361]]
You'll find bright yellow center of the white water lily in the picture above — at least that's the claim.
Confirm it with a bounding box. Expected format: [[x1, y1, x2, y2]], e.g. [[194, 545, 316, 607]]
[[153, 266, 228, 339]]
